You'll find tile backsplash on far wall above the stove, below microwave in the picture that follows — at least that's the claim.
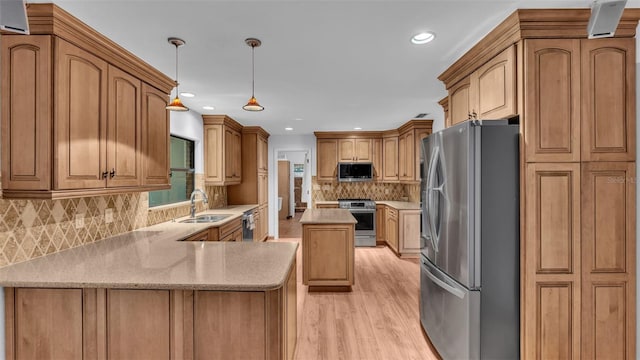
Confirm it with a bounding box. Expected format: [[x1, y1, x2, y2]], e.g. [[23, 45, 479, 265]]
[[311, 176, 412, 202]]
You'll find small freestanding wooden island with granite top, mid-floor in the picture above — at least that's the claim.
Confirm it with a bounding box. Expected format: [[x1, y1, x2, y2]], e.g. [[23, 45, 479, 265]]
[[300, 209, 357, 291]]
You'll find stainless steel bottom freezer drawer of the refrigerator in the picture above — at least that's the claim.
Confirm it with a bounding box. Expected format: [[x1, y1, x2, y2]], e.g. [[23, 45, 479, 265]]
[[420, 258, 480, 360]]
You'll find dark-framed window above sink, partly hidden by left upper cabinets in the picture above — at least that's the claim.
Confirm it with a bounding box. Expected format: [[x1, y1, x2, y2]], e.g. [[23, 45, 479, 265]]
[[149, 135, 195, 207]]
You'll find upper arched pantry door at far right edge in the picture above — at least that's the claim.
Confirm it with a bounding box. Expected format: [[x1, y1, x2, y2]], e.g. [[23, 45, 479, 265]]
[[580, 39, 636, 161]]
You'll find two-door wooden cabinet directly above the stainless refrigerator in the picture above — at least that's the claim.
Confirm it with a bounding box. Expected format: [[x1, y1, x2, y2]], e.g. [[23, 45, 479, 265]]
[[445, 45, 517, 126]]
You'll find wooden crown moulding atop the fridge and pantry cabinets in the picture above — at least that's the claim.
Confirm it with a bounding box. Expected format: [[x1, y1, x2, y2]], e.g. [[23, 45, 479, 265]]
[[438, 9, 640, 90]]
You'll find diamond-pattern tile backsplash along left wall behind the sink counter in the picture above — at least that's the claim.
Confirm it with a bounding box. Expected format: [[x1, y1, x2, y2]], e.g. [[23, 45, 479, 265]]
[[0, 174, 227, 267]]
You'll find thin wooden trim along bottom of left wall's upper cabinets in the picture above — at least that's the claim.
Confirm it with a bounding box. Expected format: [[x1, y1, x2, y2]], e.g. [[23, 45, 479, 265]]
[[2, 185, 171, 200]]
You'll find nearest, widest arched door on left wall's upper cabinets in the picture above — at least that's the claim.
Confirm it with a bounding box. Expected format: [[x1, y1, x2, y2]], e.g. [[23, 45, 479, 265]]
[[54, 39, 107, 189]]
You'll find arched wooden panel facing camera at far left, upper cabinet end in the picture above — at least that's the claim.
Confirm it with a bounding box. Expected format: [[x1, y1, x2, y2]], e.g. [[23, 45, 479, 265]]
[[1, 36, 52, 190]]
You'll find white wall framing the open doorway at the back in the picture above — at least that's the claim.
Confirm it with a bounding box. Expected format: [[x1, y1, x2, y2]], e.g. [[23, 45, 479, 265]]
[[269, 135, 316, 236]]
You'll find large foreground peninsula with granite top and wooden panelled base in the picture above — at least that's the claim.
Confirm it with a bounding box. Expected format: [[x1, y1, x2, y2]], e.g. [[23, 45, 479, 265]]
[[0, 217, 297, 359]]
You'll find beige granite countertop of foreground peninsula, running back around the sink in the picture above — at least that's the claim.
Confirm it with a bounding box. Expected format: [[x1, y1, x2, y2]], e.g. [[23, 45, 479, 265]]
[[0, 205, 298, 291]]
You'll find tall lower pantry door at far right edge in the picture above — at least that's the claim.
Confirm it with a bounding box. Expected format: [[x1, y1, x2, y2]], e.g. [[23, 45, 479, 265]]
[[581, 162, 636, 359]]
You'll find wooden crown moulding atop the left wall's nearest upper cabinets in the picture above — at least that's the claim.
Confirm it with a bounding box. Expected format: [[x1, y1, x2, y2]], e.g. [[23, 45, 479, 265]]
[[21, 4, 175, 94]]
